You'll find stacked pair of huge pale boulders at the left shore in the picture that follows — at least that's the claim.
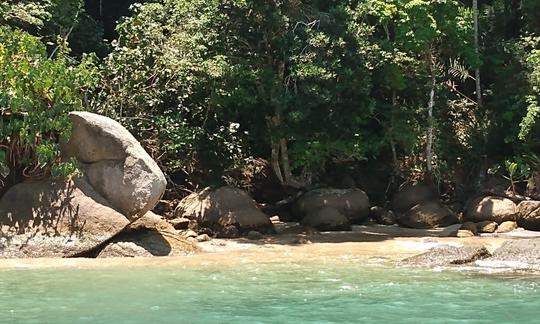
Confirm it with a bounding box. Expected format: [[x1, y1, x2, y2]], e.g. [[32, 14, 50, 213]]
[[0, 112, 196, 257]]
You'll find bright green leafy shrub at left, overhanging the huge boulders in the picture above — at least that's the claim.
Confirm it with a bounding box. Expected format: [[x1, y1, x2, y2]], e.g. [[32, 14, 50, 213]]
[[0, 26, 95, 188]]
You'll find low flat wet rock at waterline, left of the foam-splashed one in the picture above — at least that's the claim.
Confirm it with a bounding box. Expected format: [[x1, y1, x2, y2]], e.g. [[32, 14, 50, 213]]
[[401, 245, 491, 267]]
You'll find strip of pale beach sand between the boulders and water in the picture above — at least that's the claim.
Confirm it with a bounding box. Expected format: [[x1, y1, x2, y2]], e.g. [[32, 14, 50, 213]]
[[0, 226, 524, 269]]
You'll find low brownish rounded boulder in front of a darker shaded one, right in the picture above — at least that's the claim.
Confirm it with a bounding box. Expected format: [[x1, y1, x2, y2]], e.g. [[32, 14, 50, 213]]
[[398, 202, 458, 228]]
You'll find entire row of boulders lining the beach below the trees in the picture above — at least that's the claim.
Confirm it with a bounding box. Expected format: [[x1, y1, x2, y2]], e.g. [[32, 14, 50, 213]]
[[0, 112, 540, 257]]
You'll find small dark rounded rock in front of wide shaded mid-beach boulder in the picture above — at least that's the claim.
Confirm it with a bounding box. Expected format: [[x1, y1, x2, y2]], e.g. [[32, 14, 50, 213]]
[[301, 207, 351, 231]]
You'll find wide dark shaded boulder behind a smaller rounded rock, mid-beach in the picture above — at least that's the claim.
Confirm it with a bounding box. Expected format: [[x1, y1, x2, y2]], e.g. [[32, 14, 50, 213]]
[[296, 189, 370, 223]]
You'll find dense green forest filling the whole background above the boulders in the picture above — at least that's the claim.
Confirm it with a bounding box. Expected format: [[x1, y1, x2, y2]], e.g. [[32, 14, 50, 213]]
[[0, 0, 540, 197]]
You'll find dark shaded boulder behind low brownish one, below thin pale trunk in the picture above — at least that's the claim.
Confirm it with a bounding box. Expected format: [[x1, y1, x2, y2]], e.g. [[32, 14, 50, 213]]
[[392, 183, 438, 213]]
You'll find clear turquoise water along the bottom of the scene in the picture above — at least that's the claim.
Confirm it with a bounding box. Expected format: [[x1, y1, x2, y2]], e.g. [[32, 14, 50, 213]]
[[0, 261, 540, 324]]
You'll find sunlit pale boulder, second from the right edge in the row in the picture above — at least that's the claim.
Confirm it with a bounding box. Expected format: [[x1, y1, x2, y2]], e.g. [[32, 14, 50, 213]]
[[464, 196, 518, 224]]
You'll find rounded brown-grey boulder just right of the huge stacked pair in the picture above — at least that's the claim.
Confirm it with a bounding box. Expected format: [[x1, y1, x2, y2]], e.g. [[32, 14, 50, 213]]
[[175, 186, 274, 237]]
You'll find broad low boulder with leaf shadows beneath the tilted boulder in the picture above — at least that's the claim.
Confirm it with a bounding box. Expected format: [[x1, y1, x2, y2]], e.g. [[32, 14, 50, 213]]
[[0, 178, 130, 257]]
